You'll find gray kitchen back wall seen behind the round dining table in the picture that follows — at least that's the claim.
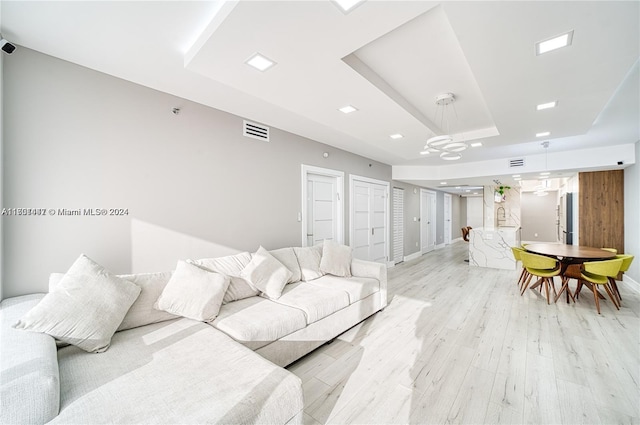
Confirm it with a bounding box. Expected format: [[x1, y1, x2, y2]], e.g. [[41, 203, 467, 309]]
[[520, 191, 558, 242]]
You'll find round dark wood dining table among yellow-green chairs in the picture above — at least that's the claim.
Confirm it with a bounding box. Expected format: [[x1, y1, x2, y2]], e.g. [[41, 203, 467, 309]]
[[523, 243, 616, 302]]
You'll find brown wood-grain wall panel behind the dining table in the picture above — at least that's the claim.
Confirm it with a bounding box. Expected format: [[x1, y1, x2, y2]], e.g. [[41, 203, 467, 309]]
[[578, 170, 624, 253]]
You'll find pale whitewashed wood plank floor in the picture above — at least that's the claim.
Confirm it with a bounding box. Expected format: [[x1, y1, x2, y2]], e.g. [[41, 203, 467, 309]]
[[289, 242, 640, 424]]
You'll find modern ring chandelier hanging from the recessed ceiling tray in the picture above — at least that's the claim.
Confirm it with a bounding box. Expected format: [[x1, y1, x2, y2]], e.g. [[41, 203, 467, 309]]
[[424, 93, 469, 161]]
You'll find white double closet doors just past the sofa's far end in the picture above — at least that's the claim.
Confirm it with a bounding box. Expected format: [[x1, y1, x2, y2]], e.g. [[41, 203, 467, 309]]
[[350, 176, 389, 263]]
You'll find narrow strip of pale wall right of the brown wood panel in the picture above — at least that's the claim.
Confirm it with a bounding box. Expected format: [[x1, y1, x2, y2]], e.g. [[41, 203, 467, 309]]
[[624, 141, 640, 283]]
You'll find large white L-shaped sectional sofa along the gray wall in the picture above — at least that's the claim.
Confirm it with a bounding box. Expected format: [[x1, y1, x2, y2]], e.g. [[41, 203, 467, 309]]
[[0, 240, 387, 424]]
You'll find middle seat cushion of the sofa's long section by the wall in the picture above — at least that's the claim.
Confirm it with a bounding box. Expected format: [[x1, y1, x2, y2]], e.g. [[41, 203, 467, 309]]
[[274, 282, 349, 324]]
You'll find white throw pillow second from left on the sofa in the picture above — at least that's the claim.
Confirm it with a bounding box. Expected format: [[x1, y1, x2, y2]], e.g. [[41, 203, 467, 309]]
[[155, 260, 229, 322]]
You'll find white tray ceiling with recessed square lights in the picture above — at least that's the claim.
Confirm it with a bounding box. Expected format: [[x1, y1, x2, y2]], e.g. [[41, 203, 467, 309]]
[[0, 0, 640, 188]]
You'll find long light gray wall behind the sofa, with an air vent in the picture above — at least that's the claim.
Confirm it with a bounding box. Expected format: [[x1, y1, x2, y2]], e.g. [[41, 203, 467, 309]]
[[2, 48, 391, 297]]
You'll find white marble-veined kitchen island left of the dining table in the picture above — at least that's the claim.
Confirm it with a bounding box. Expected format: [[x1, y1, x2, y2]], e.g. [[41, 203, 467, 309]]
[[469, 226, 520, 270]]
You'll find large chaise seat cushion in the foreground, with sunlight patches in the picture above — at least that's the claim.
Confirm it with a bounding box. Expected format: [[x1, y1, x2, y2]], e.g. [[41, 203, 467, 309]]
[[51, 319, 303, 424]]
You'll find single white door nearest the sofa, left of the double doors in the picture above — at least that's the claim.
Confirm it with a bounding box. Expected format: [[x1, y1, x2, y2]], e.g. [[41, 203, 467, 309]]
[[300, 165, 344, 246]]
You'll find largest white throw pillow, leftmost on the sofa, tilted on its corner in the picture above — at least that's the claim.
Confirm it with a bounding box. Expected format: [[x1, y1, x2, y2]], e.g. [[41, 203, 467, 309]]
[[14, 254, 140, 353]]
